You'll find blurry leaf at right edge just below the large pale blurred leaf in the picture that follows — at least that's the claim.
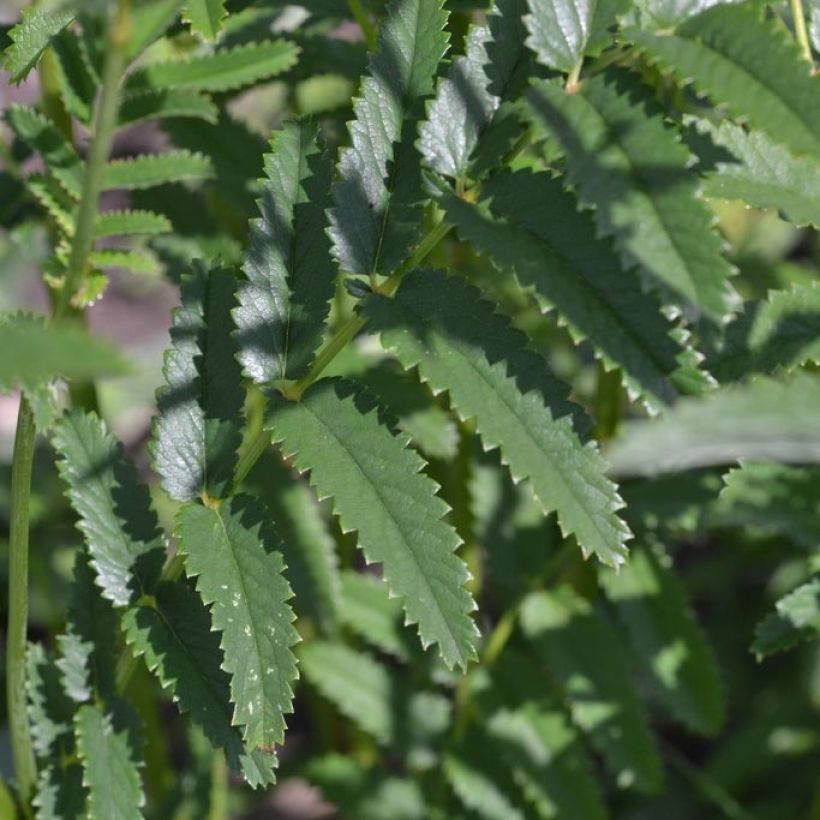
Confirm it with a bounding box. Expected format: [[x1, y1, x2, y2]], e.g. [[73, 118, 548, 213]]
[[707, 462, 820, 549]]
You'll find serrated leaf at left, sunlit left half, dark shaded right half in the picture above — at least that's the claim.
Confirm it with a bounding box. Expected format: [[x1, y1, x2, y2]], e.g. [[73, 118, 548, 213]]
[[53, 411, 165, 606]]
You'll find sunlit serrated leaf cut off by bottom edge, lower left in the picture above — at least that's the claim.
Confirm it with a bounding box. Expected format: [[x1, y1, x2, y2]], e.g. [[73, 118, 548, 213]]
[[74, 704, 145, 820]]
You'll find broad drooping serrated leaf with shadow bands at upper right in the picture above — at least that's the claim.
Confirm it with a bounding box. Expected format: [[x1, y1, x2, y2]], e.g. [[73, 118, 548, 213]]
[[526, 70, 732, 323]]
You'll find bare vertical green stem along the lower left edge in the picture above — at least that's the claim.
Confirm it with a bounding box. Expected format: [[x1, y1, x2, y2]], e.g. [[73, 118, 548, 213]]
[[6, 396, 36, 816]]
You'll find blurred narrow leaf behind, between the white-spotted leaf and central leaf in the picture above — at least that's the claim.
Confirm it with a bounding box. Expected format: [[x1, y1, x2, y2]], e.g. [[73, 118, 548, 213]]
[[244, 453, 341, 633]]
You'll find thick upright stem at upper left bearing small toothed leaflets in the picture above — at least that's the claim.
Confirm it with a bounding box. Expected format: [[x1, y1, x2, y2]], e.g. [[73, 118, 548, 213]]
[[54, 0, 131, 319]]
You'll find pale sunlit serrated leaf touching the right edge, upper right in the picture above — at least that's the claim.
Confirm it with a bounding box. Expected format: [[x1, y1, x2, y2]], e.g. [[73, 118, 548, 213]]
[[694, 120, 820, 227]]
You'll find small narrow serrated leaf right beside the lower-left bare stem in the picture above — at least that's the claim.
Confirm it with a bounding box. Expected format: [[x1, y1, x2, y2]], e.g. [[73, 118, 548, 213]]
[[26, 643, 74, 760]]
